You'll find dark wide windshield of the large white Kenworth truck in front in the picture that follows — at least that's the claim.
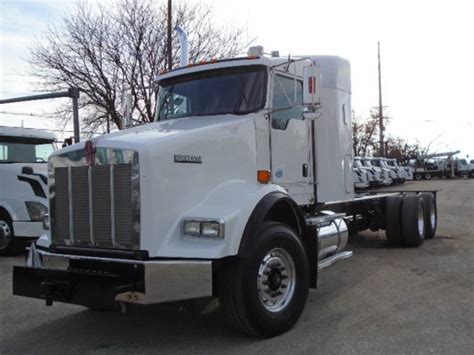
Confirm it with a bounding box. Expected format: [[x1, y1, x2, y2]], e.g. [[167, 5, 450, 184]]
[[157, 66, 267, 121]]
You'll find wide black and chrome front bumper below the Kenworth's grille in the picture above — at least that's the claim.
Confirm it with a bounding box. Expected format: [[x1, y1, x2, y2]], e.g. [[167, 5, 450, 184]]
[[13, 248, 212, 307]]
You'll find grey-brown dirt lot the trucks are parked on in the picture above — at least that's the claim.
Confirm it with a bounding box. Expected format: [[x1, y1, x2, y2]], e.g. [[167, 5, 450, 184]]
[[0, 179, 474, 354]]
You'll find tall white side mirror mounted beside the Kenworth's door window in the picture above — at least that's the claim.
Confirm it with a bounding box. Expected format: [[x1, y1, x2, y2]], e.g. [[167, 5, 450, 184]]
[[303, 60, 322, 119]]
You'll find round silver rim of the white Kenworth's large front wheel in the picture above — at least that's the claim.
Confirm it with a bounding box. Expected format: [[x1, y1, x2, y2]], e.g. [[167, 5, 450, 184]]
[[257, 248, 296, 312]]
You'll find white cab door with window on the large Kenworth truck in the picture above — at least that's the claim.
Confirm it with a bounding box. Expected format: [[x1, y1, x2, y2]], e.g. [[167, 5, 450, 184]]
[[270, 74, 314, 204]]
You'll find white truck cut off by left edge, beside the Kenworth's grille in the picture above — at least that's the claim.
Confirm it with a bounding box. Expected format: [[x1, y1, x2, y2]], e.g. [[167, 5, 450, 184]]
[[0, 127, 56, 255]]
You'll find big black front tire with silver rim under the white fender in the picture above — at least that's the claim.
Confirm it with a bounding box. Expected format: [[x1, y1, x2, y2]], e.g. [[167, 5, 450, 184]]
[[218, 222, 309, 337]]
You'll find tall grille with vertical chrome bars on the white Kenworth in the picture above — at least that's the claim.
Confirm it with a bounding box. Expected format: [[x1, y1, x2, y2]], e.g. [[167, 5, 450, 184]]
[[50, 162, 139, 249]]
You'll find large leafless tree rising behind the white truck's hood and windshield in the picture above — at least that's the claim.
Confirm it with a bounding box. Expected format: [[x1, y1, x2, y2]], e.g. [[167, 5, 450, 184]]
[[31, 0, 244, 131]]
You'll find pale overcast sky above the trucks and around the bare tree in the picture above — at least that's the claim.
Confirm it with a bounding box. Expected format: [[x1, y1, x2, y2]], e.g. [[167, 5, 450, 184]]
[[0, 0, 474, 157]]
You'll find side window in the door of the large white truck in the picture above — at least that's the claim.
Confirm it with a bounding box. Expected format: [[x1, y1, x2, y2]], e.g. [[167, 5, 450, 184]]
[[272, 75, 303, 130]]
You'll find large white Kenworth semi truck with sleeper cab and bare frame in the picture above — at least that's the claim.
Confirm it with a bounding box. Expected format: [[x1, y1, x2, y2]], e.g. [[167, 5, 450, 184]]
[[13, 48, 436, 337]]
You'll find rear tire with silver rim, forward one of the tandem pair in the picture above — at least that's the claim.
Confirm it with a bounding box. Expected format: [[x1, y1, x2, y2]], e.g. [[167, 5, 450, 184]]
[[402, 195, 426, 247]]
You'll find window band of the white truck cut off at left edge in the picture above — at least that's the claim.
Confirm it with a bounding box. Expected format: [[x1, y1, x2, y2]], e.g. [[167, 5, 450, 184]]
[[0, 137, 55, 164]]
